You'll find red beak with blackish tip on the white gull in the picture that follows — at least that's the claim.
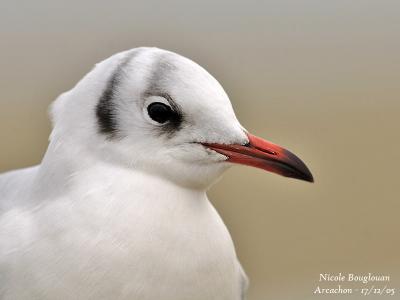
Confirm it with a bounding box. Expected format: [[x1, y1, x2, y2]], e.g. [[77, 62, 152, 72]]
[[203, 133, 314, 182]]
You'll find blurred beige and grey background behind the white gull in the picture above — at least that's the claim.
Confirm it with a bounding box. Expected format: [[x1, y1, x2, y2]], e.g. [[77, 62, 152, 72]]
[[0, 0, 400, 300]]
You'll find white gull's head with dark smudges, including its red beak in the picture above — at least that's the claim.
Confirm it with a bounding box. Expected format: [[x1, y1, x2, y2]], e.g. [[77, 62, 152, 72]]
[[51, 48, 313, 187]]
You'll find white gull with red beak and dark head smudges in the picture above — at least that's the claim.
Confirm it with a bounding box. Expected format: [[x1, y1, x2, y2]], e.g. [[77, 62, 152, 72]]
[[0, 47, 313, 300]]
